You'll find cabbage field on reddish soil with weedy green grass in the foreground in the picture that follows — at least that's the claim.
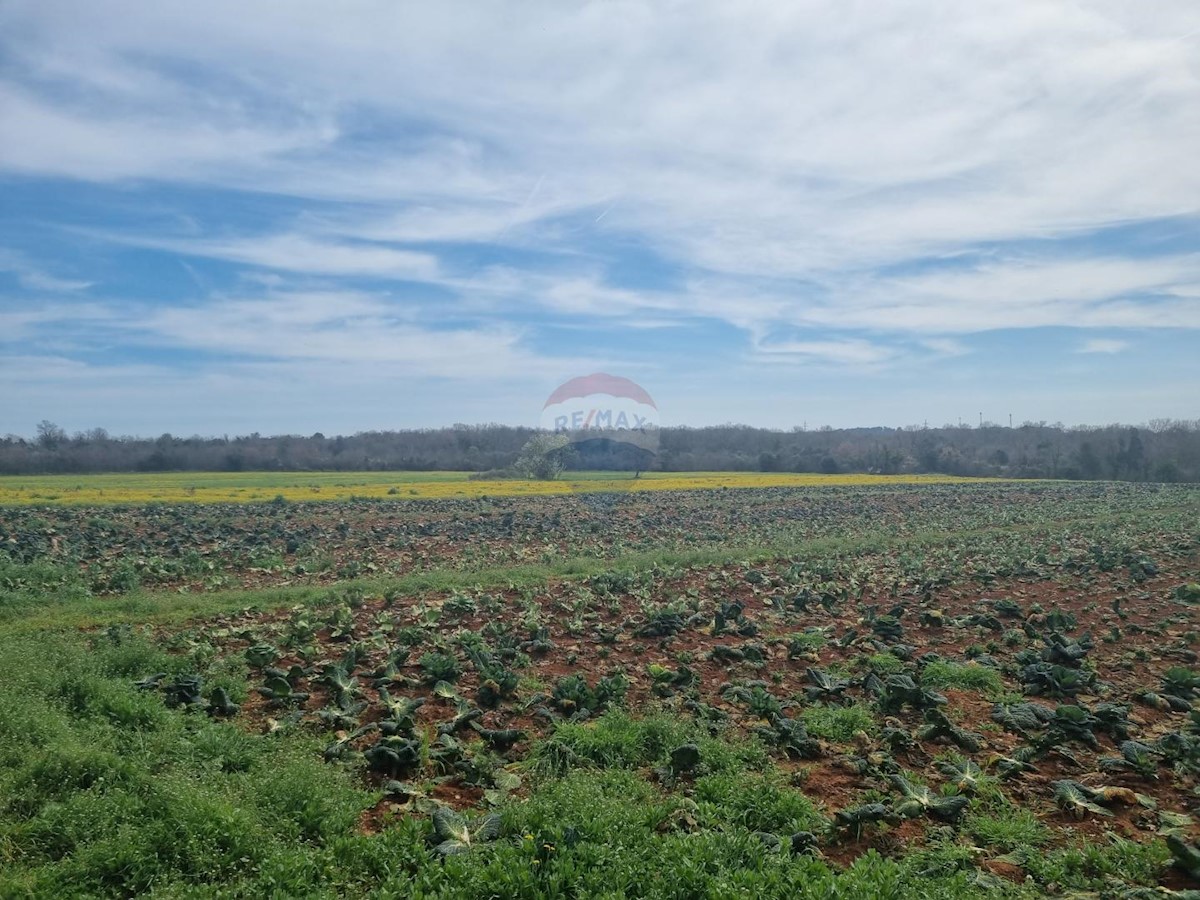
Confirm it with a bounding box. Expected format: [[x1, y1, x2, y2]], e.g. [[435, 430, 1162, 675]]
[[0, 482, 1200, 898]]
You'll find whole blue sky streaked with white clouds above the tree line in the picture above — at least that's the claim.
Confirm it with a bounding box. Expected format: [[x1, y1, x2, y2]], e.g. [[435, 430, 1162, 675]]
[[0, 0, 1200, 436]]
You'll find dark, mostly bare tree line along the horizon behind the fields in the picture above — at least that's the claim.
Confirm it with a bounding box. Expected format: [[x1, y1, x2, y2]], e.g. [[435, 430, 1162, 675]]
[[0, 419, 1200, 481]]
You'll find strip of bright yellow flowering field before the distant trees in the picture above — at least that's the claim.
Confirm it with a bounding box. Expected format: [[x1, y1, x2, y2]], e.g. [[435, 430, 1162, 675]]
[[0, 472, 988, 505]]
